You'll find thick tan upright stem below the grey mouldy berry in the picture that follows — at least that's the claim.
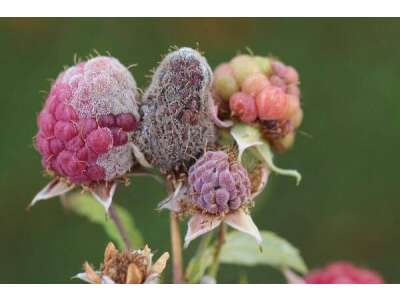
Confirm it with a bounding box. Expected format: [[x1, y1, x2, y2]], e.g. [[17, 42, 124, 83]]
[[170, 212, 184, 283]]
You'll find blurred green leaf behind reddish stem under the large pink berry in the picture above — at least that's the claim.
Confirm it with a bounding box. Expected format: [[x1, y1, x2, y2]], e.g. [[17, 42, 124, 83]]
[[64, 193, 144, 249]]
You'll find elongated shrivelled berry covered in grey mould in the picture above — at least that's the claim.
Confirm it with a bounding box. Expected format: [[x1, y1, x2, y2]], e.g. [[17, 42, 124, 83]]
[[136, 48, 216, 172]]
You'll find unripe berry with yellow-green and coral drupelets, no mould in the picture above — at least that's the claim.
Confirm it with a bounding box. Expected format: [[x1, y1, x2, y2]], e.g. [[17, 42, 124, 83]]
[[213, 55, 303, 151]]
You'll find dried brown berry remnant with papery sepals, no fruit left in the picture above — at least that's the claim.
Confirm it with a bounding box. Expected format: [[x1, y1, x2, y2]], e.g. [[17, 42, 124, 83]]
[[75, 242, 169, 284]]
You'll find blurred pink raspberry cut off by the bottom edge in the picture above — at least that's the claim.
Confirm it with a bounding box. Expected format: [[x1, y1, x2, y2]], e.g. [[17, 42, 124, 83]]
[[304, 262, 384, 284]]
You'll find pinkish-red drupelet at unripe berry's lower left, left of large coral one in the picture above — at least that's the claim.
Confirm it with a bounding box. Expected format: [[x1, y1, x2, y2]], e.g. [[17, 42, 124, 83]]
[[229, 92, 257, 123]]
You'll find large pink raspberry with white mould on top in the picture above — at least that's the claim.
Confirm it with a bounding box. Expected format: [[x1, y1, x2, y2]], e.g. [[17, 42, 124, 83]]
[[35, 56, 139, 184]]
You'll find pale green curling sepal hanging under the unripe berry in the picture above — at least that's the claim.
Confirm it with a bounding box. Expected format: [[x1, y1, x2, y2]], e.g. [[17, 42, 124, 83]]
[[231, 123, 301, 184]]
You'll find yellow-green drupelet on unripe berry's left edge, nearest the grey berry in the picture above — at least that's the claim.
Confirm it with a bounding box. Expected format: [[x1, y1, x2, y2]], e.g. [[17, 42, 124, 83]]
[[213, 63, 239, 100]]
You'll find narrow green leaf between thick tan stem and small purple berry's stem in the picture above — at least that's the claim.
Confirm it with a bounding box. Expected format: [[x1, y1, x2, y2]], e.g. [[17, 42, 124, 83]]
[[185, 234, 213, 283]]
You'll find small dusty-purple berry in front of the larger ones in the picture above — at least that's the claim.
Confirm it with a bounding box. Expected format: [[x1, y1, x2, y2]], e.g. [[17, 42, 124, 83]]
[[188, 151, 251, 214]]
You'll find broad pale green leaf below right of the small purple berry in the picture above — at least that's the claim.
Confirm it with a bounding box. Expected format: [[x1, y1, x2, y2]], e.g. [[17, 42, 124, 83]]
[[220, 231, 307, 274]]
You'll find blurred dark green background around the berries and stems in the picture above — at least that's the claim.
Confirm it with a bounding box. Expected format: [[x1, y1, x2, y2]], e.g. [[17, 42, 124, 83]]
[[0, 19, 400, 283]]
